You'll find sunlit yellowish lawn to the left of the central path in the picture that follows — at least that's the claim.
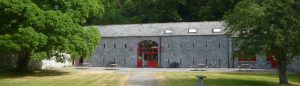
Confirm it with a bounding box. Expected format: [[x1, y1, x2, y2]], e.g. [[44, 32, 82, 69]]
[[0, 69, 126, 86]]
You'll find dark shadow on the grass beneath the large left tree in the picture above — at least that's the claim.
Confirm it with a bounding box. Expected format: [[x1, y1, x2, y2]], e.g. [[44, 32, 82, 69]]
[[0, 70, 70, 79]]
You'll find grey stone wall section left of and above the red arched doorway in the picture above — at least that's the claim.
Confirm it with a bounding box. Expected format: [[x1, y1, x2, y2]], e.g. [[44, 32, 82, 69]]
[[87, 37, 160, 67]]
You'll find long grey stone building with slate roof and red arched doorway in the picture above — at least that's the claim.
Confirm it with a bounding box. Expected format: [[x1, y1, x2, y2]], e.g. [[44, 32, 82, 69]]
[[87, 21, 300, 71]]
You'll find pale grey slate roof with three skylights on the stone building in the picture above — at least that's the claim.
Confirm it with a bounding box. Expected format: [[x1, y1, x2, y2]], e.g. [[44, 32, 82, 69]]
[[95, 21, 225, 37]]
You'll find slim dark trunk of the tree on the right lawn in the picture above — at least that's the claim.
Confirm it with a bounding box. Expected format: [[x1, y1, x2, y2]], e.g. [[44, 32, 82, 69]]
[[278, 60, 289, 84]]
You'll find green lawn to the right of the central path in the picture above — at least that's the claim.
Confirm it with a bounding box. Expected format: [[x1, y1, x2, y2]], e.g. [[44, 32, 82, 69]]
[[155, 72, 300, 86]]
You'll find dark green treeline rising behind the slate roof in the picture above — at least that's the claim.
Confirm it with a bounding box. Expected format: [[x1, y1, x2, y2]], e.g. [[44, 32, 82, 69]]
[[89, 0, 240, 24]]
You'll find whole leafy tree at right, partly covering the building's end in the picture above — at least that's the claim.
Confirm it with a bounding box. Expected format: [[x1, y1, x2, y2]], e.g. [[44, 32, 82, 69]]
[[225, 0, 300, 84]]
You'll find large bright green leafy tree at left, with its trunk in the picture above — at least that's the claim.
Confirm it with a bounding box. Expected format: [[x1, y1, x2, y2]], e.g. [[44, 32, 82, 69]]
[[0, 0, 103, 72]]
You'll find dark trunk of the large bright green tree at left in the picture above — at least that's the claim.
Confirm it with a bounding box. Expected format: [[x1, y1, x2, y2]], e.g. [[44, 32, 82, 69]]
[[16, 51, 30, 73]]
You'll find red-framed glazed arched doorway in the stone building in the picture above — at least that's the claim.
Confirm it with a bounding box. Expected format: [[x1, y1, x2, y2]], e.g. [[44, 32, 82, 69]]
[[137, 40, 158, 67]]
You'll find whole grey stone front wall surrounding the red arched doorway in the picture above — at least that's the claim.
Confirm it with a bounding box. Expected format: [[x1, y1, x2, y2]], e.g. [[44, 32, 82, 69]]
[[87, 35, 229, 68]]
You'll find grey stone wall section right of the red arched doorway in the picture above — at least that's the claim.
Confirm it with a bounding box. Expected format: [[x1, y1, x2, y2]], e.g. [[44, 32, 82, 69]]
[[161, 36, 229, 68]]
